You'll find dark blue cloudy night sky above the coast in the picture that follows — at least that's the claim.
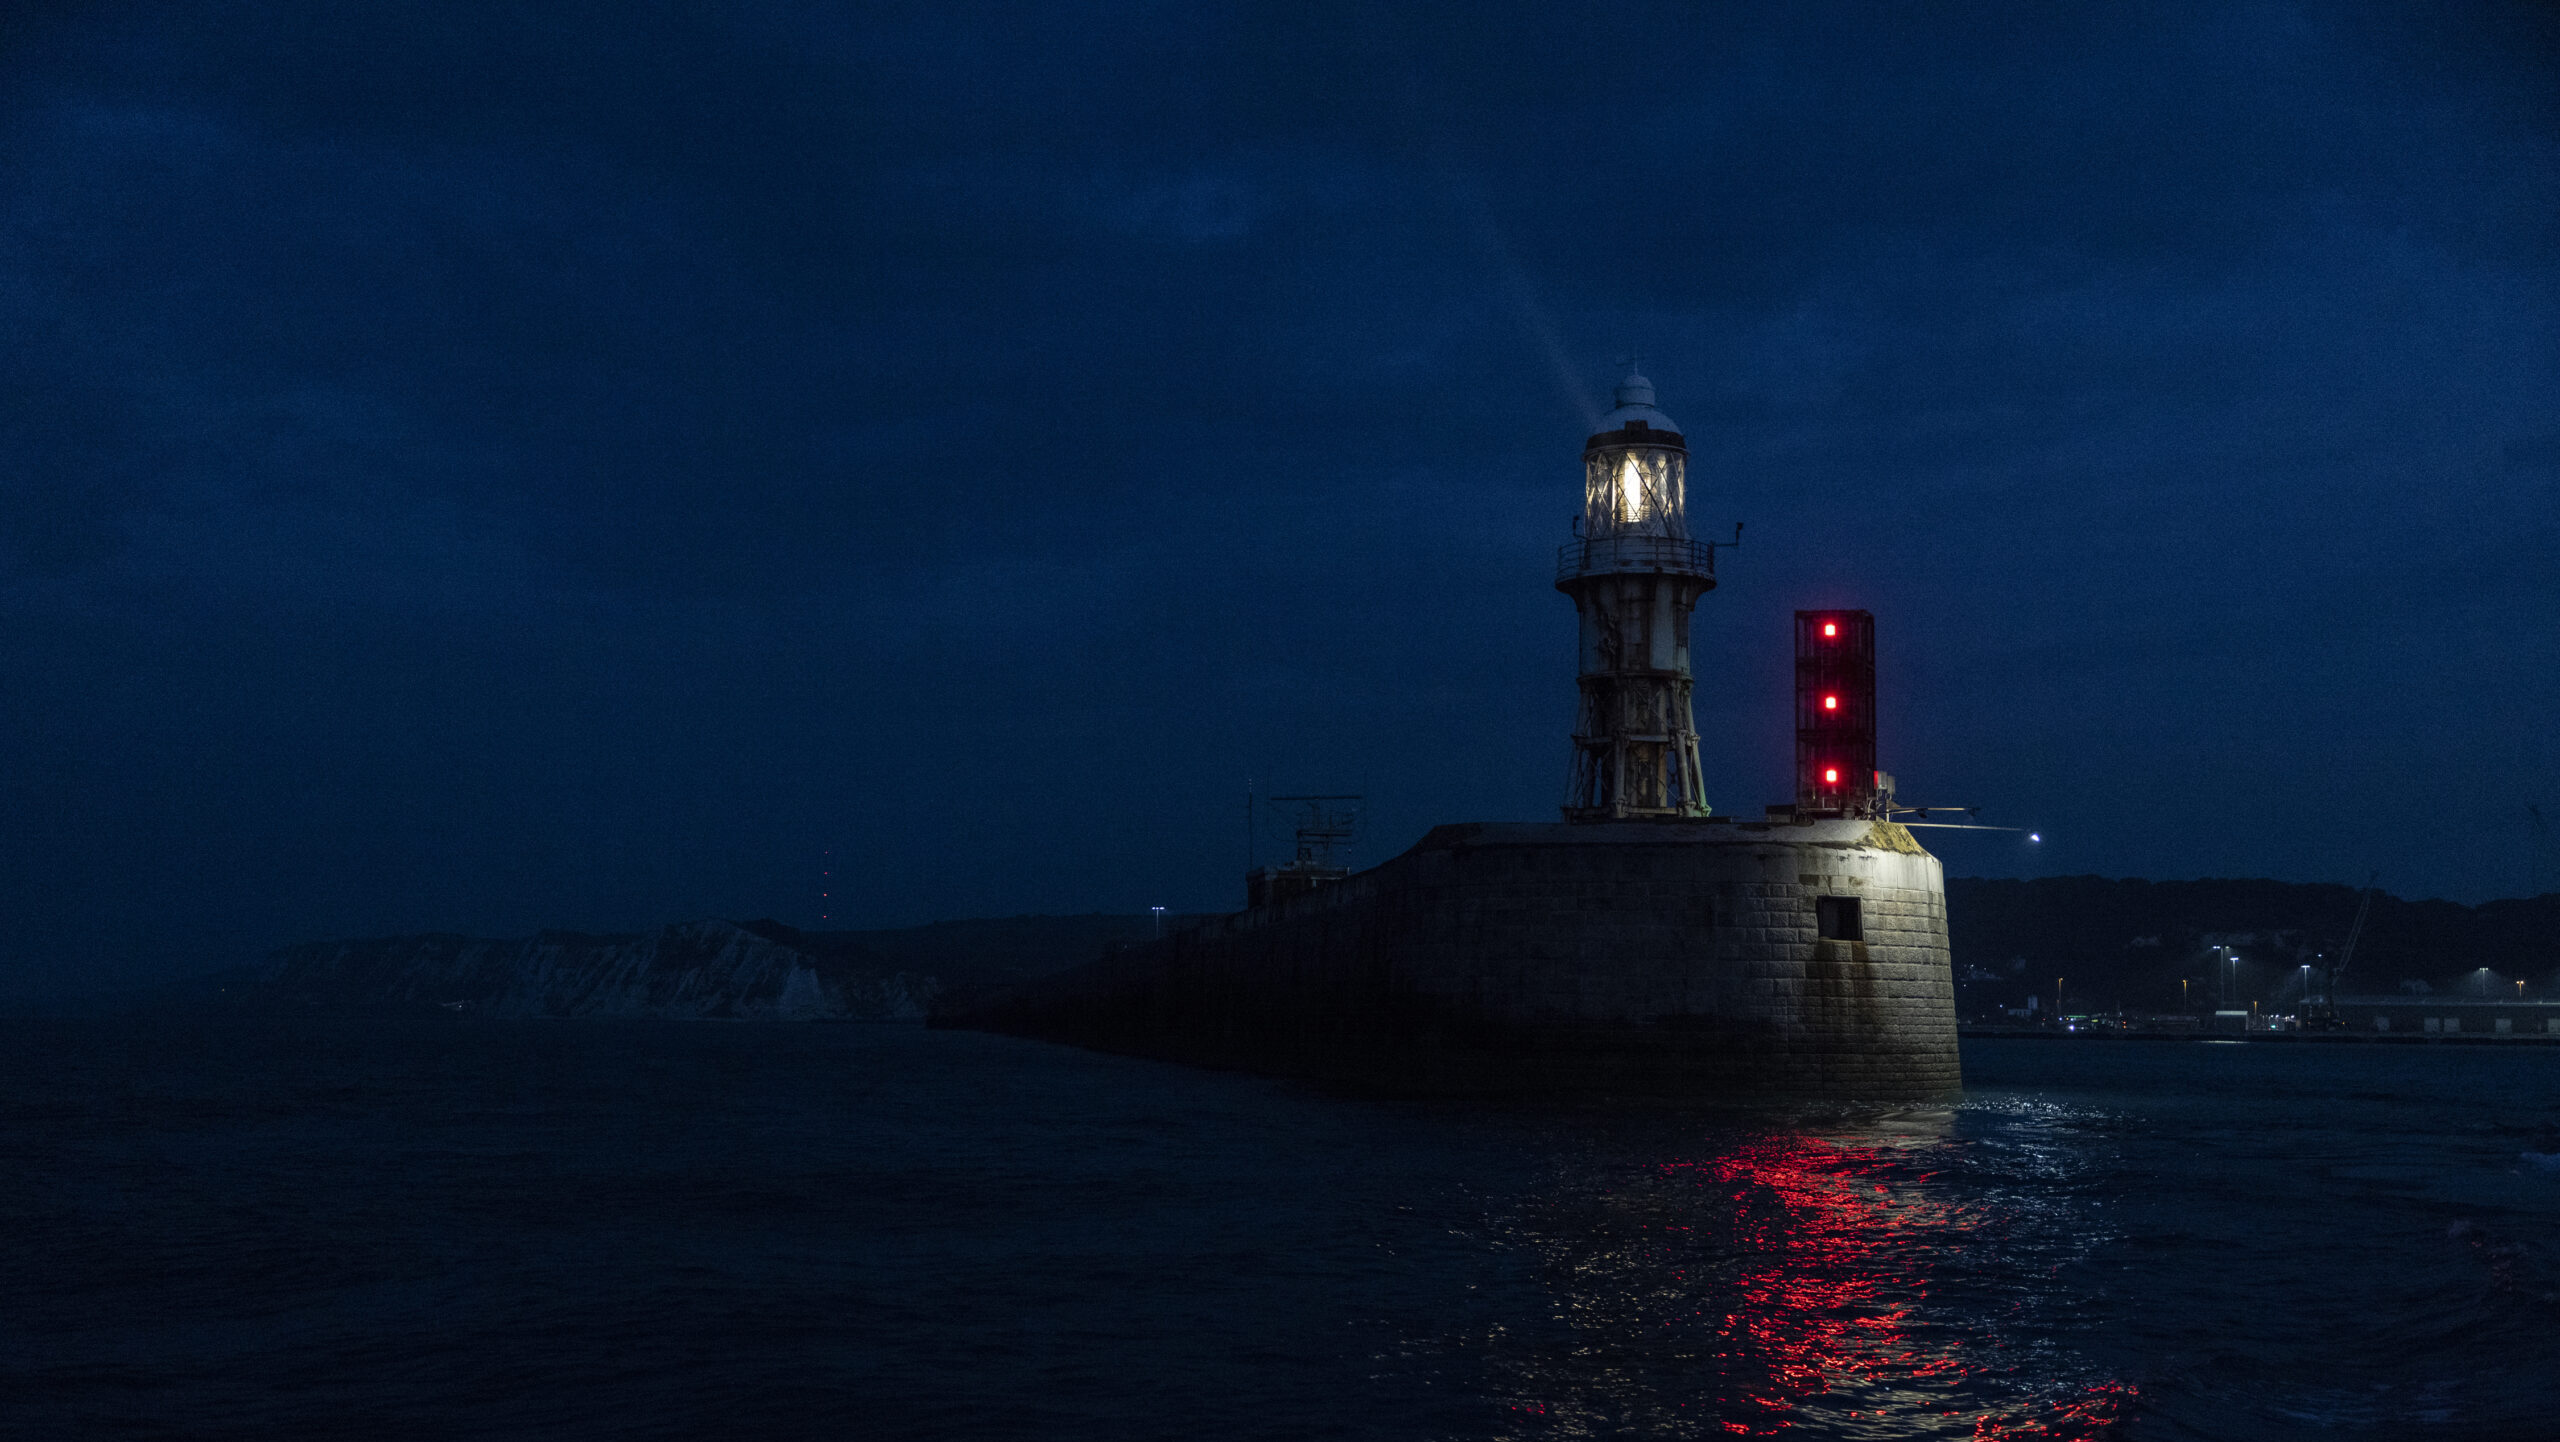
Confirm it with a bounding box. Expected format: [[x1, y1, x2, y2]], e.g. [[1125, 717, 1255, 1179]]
[[0, 0, 2560, 991]]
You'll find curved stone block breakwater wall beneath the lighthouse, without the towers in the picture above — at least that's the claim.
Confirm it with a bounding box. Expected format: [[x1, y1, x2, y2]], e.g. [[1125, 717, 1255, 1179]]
[[932, 822, 1961, 1101]]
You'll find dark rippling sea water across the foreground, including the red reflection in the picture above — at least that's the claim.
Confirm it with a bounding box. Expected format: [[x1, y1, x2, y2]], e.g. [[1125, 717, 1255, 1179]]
[[0, 1019, 2560, 1439]]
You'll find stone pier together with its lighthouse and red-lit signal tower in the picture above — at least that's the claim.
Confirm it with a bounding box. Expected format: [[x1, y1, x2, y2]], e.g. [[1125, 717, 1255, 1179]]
[[934, 371, 1961, 1099]]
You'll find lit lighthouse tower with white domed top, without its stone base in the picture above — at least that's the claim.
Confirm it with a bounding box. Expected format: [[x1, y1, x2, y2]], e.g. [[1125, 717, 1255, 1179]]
[[1556, 369, 1715, 822]]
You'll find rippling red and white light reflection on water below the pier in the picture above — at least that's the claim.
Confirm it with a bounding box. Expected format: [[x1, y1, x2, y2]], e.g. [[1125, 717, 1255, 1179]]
[[1523, 1135, 2138, 1442]]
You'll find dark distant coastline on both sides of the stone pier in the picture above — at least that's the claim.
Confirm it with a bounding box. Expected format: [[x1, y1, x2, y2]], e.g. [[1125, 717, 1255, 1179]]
[[104, 876, 2560, 1019]]
